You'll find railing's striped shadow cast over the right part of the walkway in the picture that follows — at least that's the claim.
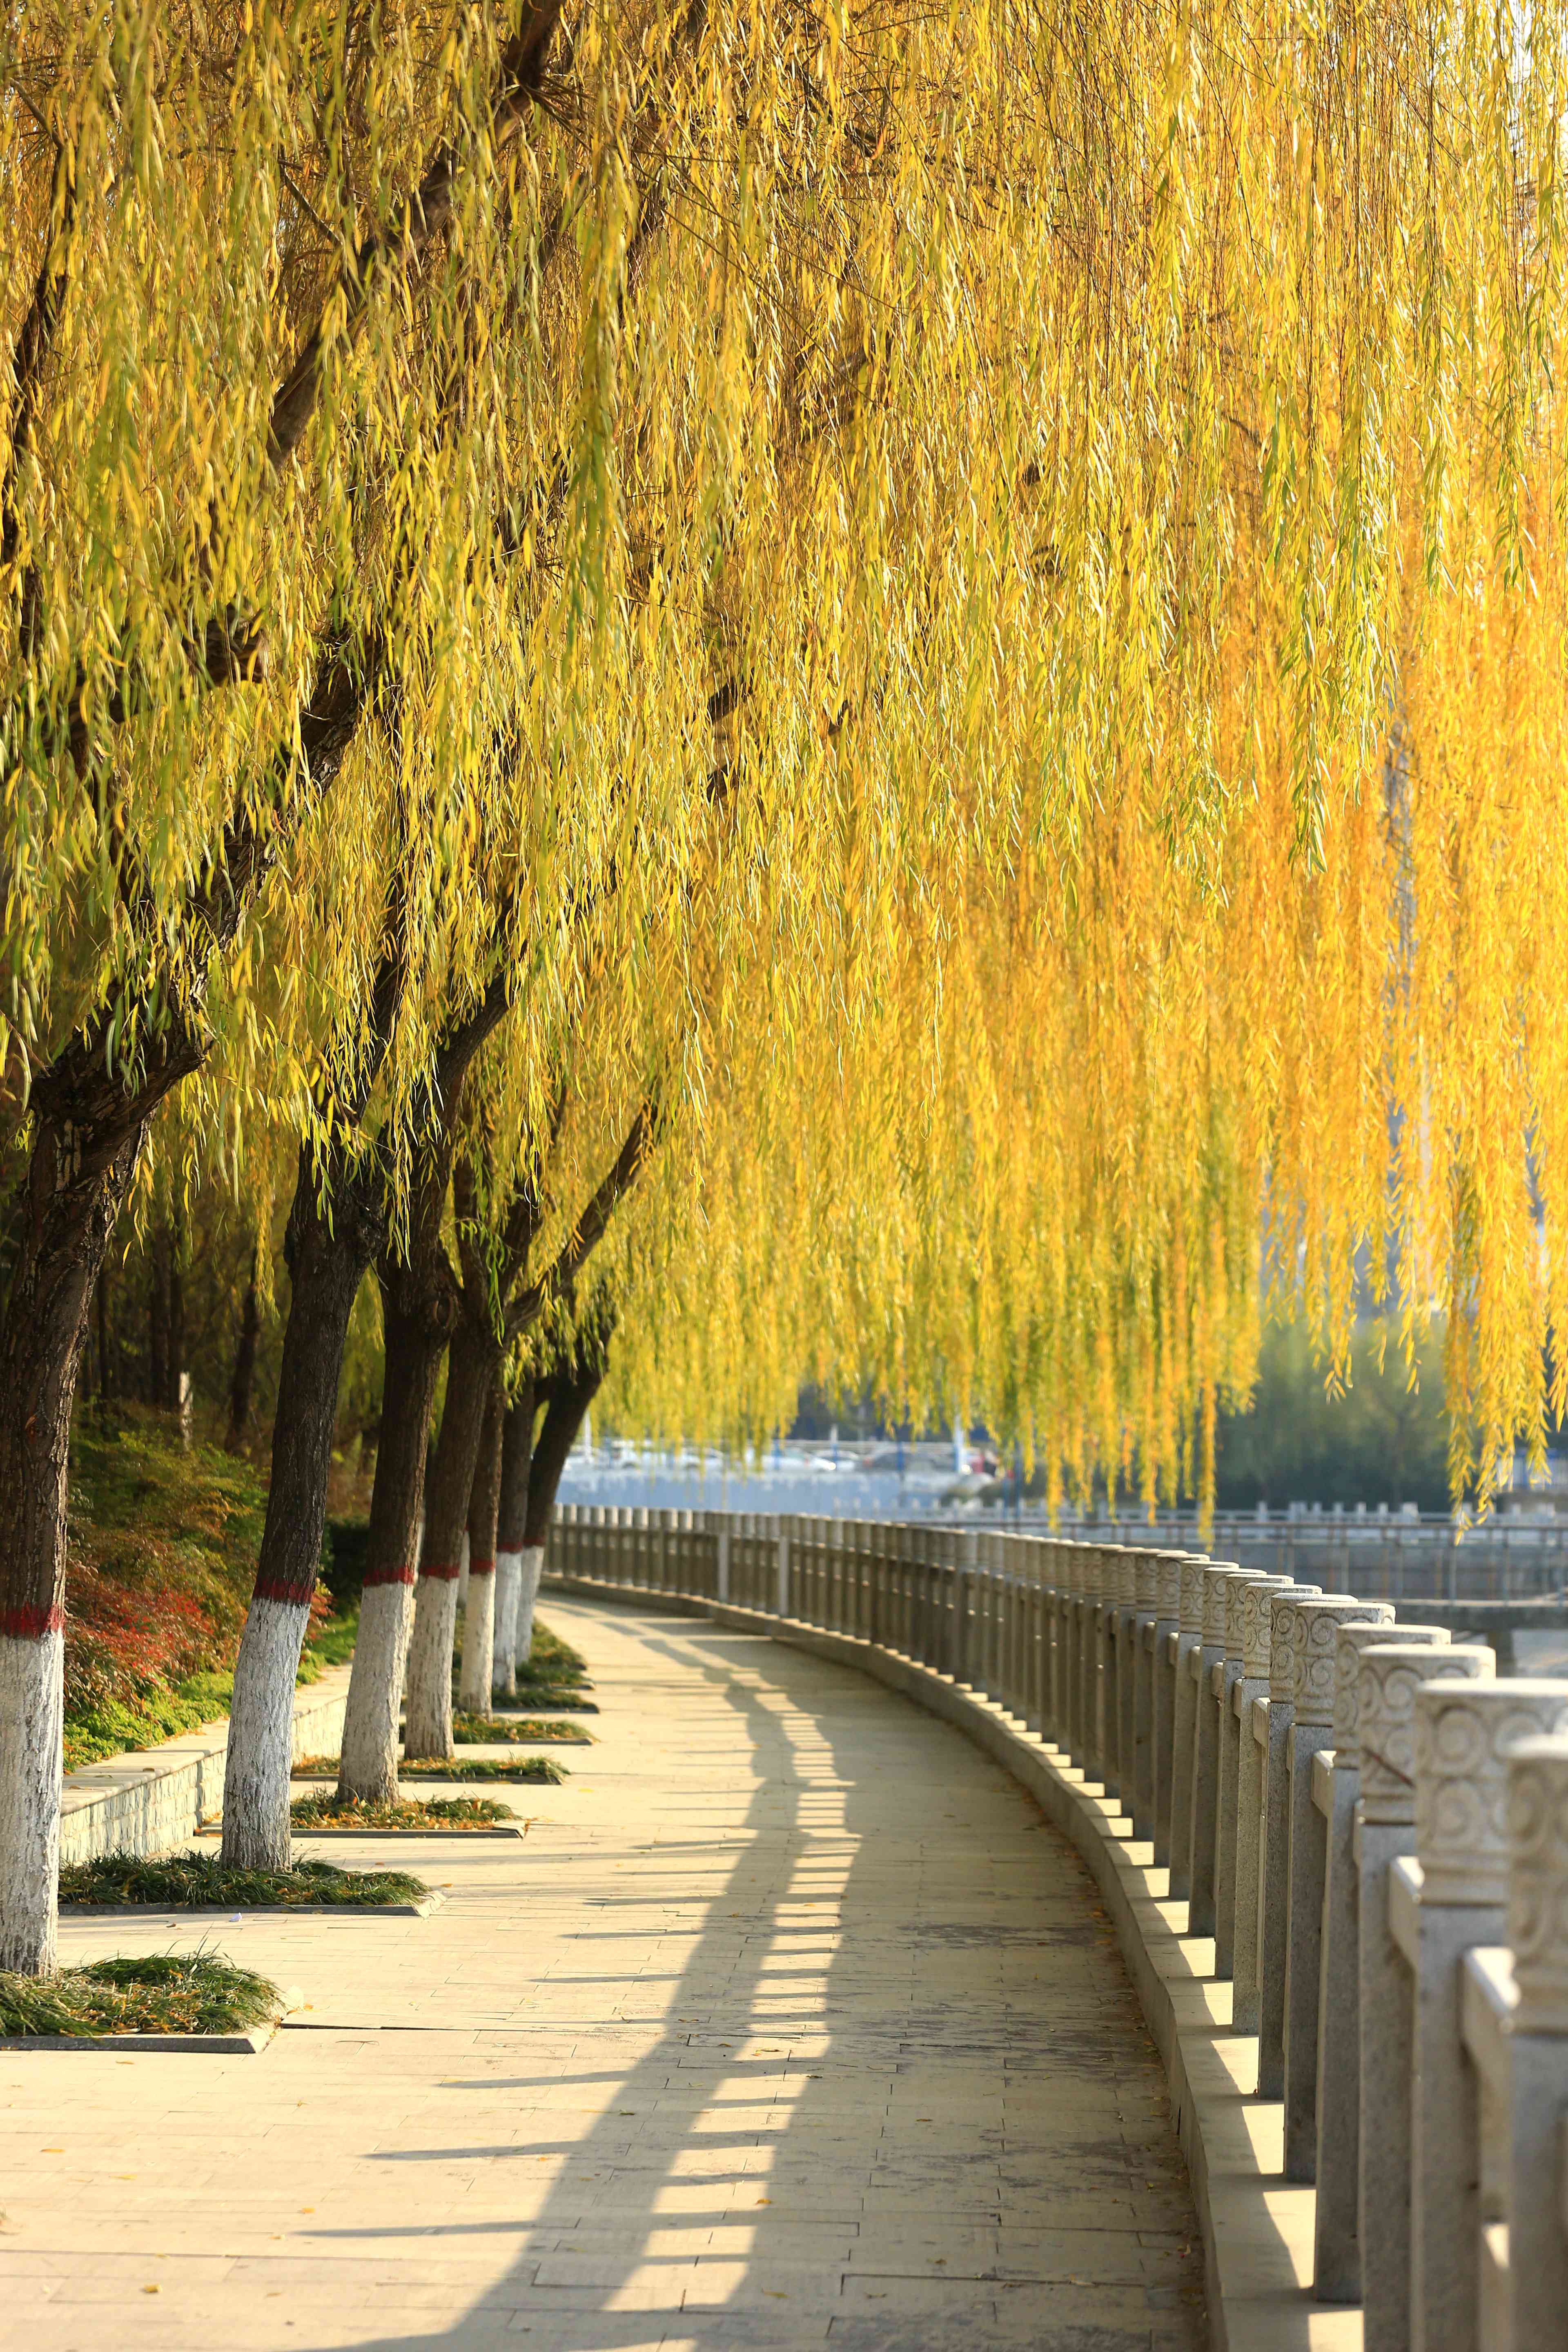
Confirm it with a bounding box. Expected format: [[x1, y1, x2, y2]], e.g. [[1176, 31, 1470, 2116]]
[[334, 1618, 1201, 2352]]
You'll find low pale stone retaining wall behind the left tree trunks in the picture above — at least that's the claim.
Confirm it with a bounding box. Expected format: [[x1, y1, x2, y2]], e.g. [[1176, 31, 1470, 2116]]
[[59, 1665, 350, 1863]]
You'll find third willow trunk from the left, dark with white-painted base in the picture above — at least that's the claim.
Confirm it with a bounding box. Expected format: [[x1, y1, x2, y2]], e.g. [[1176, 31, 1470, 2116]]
[[339, 1265, 451, 1804]]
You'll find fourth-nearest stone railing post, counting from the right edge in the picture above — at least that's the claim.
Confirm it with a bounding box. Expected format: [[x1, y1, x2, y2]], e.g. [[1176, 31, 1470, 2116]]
[[1312, 1625, 1450, 2303]]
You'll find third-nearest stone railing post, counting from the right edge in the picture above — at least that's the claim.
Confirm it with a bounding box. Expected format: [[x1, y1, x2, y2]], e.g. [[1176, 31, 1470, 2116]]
[[1356, 1656, 1497, 2352]]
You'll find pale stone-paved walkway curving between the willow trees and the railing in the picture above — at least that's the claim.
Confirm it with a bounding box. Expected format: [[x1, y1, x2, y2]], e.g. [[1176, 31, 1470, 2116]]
[[0, 1599, 1204, 2352]]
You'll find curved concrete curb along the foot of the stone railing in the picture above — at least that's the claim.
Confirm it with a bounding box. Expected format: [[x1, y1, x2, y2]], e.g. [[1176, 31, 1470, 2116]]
[[543, 1573, 1361, 2352]]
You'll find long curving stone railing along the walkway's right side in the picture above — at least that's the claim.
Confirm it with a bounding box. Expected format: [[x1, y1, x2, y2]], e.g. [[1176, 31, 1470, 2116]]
[[546, 1505, 1568, 2352]]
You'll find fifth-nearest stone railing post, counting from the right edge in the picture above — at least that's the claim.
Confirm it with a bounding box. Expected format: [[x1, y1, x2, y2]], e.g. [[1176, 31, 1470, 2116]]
[[1283, 1597, 1394, 2180]]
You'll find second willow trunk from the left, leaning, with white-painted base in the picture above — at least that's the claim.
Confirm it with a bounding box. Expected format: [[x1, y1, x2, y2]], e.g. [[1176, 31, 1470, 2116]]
[[223, 1148, 385, 1870]]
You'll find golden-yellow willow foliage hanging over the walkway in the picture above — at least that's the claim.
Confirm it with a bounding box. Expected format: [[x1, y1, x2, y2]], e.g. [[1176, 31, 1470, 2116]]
[[0, 0, 1568, 1496]]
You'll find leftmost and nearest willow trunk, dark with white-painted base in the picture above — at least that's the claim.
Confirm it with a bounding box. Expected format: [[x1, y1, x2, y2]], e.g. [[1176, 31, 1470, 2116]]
[[0, 1103, 146, 1976]]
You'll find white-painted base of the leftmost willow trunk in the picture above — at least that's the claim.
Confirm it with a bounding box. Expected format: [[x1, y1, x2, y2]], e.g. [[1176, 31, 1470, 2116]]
[[0, 1628, 66, 1976]]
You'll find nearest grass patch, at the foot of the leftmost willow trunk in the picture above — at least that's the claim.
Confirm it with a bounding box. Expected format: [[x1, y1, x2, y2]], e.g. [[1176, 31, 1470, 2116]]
[[0, 1952, 282, 2037]]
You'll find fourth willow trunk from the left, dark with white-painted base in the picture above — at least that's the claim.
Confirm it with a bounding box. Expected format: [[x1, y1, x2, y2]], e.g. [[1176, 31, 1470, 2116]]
[[402, 1317, 501, 1757]]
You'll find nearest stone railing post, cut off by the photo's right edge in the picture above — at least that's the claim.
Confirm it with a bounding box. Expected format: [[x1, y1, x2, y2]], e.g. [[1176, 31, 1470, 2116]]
[[1507, 1733, 1568, 2352]]
